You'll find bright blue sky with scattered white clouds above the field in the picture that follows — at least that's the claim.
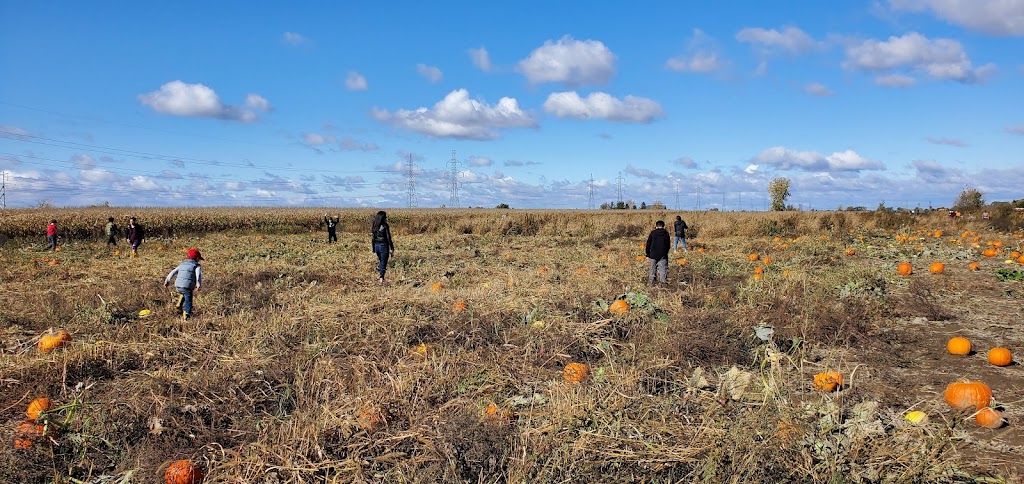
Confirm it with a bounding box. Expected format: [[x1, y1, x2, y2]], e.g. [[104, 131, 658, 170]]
[[0, 0, 1024, 210]]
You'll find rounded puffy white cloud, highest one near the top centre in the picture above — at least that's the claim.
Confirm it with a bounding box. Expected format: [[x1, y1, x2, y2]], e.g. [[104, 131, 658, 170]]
[[516, 36, 615, 87]]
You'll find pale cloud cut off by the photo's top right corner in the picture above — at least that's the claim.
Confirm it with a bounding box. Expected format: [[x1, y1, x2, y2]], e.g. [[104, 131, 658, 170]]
[[889, 0, 1024, 36]]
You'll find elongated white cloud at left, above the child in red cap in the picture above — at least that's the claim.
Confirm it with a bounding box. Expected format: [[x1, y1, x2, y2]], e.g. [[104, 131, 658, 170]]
[[138, 81, 270, 123]]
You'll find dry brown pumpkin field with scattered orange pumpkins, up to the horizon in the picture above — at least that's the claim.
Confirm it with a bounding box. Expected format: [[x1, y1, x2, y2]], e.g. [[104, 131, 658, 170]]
[[0, 208, 1024, 483]]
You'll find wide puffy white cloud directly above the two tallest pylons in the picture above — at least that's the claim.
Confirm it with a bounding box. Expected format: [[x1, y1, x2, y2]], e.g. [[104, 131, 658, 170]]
[[372, 89, 537, 139]]
